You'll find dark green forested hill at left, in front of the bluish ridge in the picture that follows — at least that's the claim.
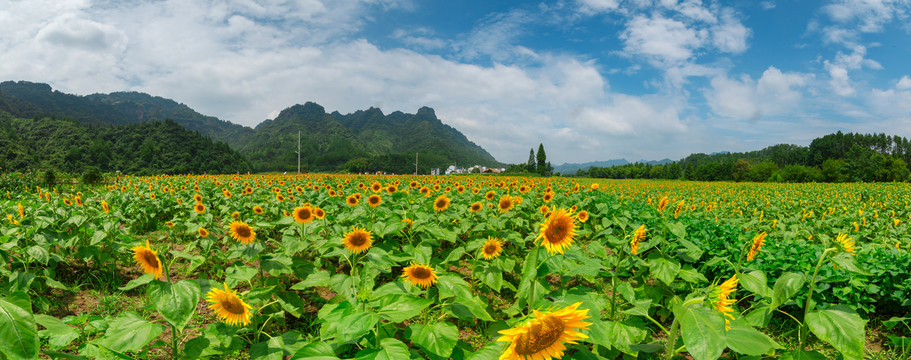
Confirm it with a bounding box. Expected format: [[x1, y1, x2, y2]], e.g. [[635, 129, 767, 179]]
[[0, 111, 252, 175]]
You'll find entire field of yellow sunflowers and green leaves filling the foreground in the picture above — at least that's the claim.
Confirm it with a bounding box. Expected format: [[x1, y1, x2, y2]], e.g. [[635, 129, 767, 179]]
[[0, 174, 911, 360]]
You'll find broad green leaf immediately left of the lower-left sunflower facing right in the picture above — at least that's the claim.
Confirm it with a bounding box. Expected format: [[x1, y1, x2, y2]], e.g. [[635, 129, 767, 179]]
[[146, 280, 200, 331]]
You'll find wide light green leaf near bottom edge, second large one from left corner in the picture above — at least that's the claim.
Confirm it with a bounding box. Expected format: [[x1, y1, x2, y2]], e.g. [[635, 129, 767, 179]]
[[96, 311, 164, 352]]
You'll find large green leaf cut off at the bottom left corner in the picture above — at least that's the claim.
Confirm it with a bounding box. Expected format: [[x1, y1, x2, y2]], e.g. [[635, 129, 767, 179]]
[[0, 292, 39, 359]]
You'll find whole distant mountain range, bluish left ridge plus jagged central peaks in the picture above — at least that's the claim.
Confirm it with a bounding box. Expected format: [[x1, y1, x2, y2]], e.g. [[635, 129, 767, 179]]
[[0, 81, 503, 173]]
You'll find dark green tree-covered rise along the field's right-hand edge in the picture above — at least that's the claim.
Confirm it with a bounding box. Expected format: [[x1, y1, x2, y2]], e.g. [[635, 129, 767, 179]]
[[576, 131, 911, 182]]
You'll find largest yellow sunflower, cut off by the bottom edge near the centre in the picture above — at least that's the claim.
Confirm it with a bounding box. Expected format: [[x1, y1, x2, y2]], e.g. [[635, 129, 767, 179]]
[[497, 302, 591, 360]]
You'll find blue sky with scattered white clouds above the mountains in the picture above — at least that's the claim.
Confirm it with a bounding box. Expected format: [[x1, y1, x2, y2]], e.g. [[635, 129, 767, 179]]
[[0, 0, 911, 164]]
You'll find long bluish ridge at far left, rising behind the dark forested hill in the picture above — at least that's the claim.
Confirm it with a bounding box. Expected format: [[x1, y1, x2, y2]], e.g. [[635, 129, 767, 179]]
[[0, 81, 253, 149]]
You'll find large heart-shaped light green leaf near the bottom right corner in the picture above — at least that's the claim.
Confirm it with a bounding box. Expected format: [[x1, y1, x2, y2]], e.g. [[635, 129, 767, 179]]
[[806, 305, 867, 359]]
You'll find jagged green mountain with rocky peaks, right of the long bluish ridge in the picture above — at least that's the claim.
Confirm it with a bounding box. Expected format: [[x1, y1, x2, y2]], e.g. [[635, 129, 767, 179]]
[[240, 102, 500, 173]]
